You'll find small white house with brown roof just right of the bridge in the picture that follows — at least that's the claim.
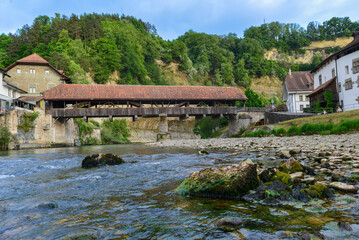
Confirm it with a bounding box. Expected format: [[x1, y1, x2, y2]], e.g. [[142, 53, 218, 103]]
[[283, 70, 314, 113]]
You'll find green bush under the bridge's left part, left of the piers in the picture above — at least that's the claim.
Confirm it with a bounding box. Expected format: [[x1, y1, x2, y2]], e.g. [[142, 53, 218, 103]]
[[101, 119, 130, 144]]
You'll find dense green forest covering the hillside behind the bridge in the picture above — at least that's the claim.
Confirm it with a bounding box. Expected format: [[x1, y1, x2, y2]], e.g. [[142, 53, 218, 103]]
[[0, 13, 359, 87]]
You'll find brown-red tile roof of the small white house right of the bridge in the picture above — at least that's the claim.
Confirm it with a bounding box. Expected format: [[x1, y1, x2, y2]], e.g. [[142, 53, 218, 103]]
[[284, 72, 314, 92]]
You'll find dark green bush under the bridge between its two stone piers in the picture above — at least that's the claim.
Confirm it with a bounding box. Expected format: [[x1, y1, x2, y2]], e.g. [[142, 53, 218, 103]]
[[193, 117, 228, 139]]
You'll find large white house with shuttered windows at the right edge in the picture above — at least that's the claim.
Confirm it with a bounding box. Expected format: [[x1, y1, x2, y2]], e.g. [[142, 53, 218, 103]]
[[309, 32, 359, 111]]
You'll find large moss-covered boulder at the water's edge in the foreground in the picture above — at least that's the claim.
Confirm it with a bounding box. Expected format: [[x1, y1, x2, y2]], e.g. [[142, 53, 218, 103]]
[[177, 163, 259, 199]]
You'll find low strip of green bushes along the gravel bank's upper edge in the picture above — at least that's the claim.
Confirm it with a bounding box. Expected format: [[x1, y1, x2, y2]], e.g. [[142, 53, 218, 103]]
[[243, 119, 359, 137]]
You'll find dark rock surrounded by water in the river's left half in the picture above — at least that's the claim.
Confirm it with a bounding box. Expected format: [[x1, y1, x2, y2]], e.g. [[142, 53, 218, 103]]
[[81, 153, 125, 168]]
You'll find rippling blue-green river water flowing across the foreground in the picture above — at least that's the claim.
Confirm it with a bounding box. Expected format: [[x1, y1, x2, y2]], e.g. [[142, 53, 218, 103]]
[[0, 144, 359, 239]]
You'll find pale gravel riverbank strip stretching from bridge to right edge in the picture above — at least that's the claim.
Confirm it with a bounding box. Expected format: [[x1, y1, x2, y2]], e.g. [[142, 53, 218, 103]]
[[147, 133, 359, 153]]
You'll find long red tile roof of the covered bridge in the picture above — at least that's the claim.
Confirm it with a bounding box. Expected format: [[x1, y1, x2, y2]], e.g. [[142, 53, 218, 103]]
[[43, 84, 247, 101]]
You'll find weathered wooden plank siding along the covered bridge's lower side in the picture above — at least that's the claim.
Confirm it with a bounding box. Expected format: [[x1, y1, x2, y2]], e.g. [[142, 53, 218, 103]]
[[46, 107, 243, 118]]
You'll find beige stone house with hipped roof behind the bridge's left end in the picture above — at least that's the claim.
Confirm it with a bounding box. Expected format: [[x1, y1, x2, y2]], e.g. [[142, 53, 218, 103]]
[[5, 53, 71, 96]]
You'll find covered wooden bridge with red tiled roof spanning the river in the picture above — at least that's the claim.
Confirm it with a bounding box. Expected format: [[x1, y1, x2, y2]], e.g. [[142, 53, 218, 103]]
[[43, 84, 247, 120]]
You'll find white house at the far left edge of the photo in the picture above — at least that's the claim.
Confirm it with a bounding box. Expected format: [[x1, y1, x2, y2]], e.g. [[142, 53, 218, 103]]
[[0, 68, 26, 113]]
